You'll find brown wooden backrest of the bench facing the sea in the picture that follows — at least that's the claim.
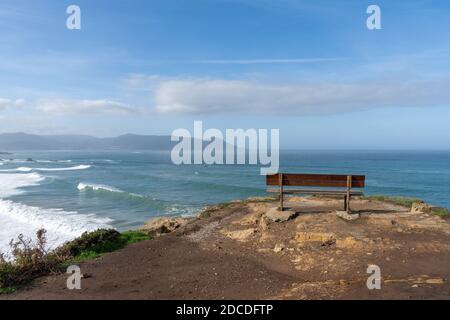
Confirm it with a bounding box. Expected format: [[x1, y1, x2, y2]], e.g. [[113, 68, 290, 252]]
[[266, 173, 366, 188]]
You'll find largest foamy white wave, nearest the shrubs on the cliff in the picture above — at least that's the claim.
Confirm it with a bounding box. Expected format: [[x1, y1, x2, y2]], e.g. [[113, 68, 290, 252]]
[[0, 199, 112, 253]]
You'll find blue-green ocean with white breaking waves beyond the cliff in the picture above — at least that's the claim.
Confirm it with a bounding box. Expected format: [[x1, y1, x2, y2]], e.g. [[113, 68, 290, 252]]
[[0, 151, 450, 252]]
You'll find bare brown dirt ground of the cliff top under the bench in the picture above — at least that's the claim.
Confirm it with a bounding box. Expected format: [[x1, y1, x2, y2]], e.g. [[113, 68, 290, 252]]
[[1, 198, 450, 299]]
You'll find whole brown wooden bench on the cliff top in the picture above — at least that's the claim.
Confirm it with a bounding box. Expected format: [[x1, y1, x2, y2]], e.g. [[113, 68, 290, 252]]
[[266, 173, 366, 212]]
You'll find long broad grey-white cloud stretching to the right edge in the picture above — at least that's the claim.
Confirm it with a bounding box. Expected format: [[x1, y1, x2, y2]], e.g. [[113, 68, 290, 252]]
[[154, 79, 450, 116]]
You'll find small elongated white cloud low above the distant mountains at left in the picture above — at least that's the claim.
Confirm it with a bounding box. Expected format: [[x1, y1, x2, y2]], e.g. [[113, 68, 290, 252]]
[[35, 99, 138, 115]]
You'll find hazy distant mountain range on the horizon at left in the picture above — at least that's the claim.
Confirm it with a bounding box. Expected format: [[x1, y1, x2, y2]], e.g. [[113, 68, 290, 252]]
[[0, 133, 174, 152]]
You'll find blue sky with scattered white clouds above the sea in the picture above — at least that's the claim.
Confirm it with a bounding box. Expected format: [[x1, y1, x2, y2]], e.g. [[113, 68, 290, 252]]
[[0, 0, 450, 150]]
